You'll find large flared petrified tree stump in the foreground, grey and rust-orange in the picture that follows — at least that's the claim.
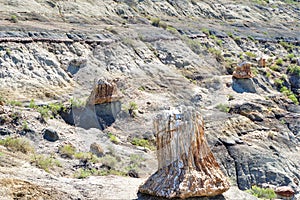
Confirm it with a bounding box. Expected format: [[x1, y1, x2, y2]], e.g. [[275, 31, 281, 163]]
[[139, 110, 229, 198]]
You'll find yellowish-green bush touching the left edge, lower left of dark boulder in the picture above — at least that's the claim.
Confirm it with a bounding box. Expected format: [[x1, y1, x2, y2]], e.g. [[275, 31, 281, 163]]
[[0, 137, 34, 154]]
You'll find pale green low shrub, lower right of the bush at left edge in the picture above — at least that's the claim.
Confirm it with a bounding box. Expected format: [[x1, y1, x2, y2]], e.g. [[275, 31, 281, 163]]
[[31, 154, 61, 172]]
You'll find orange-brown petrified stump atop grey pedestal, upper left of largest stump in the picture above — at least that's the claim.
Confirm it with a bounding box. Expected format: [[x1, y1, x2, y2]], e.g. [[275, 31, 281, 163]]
[[88, 79, 122, 105]]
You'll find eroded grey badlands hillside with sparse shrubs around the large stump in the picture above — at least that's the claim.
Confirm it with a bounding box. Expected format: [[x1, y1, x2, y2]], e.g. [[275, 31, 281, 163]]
[[0, 0, 300, 200]]
